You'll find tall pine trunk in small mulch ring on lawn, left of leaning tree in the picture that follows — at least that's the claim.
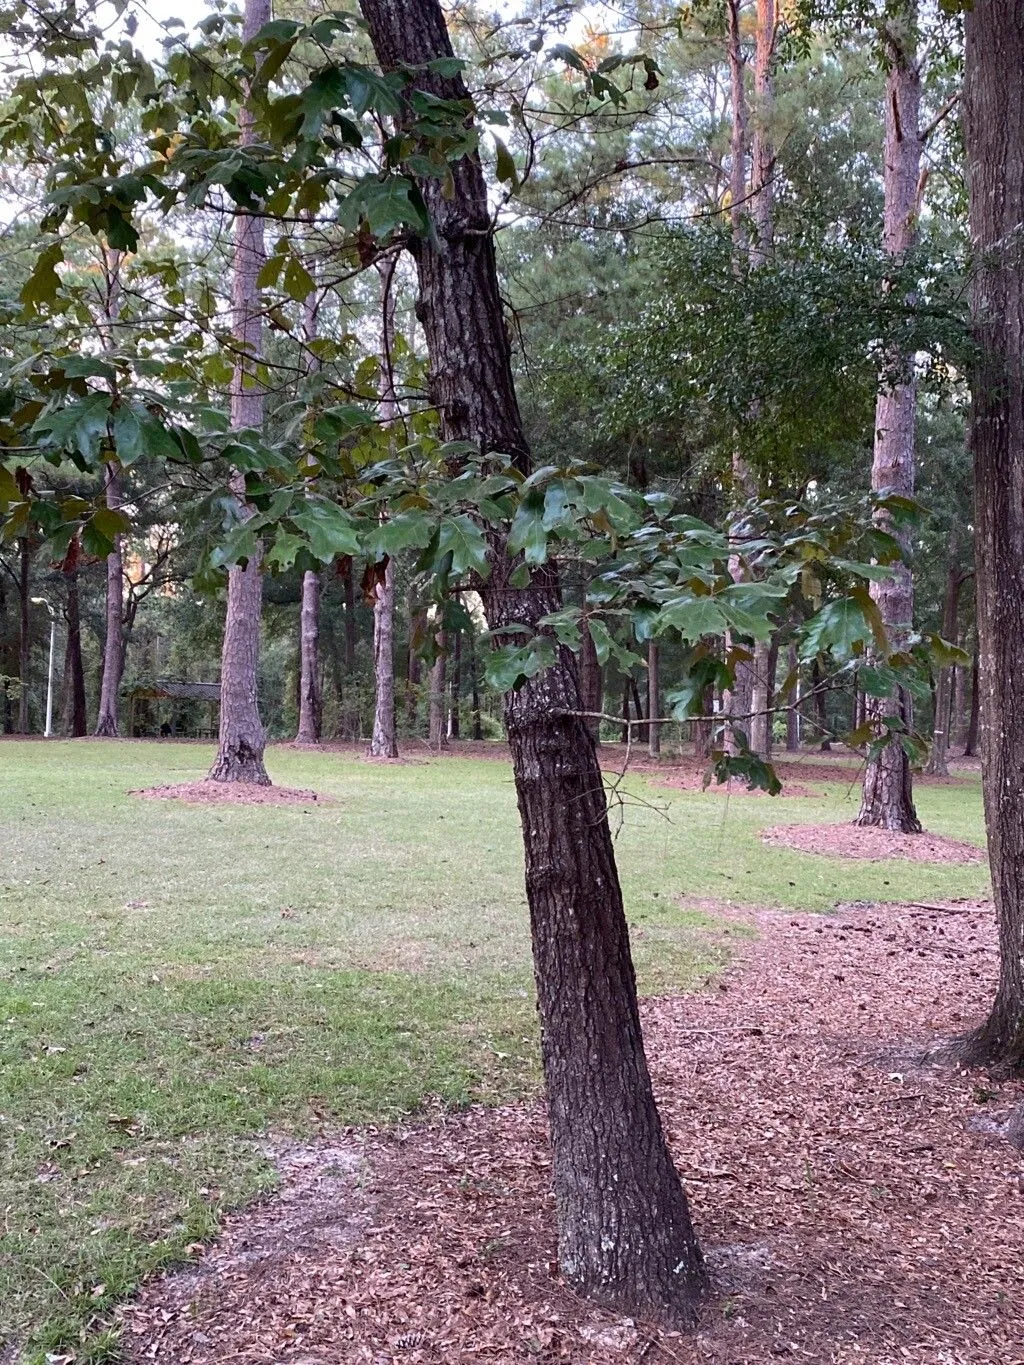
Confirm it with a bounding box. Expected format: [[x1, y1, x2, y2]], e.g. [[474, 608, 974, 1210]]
[[209, 0, 270, 786]]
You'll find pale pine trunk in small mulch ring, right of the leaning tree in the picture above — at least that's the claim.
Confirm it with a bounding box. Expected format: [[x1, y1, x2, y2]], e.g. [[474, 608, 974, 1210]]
[[856, 8, 922, 834]]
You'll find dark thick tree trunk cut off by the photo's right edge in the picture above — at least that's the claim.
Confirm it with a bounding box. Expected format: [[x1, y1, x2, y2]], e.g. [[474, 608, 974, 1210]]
[[964, 0, 1024, 1072]]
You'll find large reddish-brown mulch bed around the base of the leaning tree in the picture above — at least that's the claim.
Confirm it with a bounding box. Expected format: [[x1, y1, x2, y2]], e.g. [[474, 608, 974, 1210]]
[[123, 904, 1024, 1365]]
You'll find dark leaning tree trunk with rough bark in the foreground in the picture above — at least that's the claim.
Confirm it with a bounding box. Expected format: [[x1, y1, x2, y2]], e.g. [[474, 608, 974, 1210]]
[[362, 0, 706, 1323]]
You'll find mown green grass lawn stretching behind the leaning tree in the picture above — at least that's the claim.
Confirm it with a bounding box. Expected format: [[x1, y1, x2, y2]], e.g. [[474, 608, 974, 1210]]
[[0, 741, 987, 1362]]
